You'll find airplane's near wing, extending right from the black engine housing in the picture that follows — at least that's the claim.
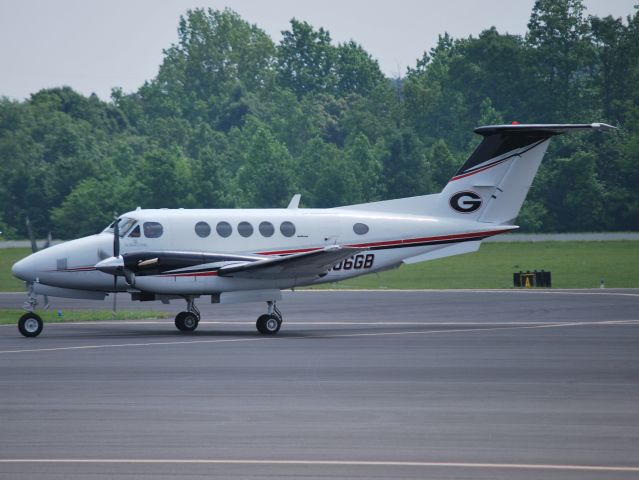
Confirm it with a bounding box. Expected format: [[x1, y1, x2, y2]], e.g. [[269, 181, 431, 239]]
[[218, 245, 367, 279]]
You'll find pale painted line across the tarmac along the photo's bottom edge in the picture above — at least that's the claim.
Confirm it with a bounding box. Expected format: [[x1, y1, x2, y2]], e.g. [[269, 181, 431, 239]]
[[0, 458, 639, 472]]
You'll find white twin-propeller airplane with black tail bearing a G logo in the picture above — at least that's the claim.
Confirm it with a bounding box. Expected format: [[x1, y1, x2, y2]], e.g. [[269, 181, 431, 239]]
[[12, 123, 614, 337]]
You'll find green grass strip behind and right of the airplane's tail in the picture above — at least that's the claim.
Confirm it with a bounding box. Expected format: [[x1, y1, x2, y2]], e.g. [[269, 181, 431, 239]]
[[313, 241, 639, 289]]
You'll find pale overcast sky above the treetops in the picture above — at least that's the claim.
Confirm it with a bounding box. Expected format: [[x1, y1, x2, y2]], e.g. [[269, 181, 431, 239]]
[[0, 0, 639, 100]]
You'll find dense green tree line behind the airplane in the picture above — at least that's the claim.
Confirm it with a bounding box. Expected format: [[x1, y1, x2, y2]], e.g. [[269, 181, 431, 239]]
[[0, 0, 639, 238]]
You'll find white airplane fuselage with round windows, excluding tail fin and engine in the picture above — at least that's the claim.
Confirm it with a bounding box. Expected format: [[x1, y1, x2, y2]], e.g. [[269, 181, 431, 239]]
[[14, 209, 512, 295]]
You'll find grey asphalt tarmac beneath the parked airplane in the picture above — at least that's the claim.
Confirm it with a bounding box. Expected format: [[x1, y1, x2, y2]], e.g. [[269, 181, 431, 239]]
[[0, 290, 639, 479]]
